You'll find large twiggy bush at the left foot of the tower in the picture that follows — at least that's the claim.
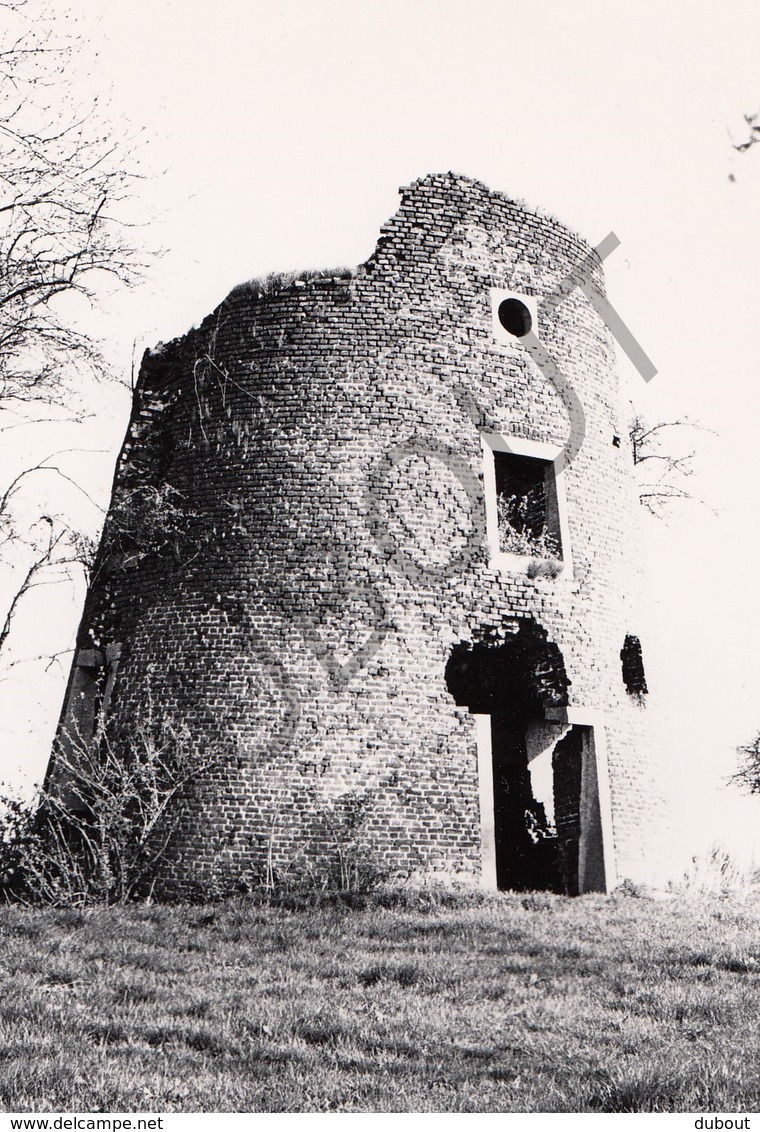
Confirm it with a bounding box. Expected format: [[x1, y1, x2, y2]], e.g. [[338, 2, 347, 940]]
[[0, 723, 224, 906]]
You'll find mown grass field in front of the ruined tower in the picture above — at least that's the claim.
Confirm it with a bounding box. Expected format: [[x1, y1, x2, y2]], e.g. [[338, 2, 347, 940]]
[[0, 894, 760, 1113]]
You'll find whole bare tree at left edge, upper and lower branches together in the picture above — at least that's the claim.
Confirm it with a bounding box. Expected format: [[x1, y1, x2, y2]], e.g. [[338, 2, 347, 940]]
[[0, 0, 140, 670]]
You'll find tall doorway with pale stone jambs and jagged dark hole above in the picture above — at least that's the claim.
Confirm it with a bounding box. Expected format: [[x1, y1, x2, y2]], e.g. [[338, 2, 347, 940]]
[[446, 619, 606, 895]]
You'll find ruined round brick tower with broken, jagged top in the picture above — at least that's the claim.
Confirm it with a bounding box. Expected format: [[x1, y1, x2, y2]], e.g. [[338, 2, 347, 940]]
[[52, 174, 659, 893]]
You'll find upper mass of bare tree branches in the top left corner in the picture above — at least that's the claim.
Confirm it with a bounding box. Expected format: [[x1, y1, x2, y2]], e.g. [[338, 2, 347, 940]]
[[0, 0, 142, 409]]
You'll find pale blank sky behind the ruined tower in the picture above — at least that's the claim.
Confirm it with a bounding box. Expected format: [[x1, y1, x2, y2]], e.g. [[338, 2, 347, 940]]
[[0, 0, 760, 869]]
